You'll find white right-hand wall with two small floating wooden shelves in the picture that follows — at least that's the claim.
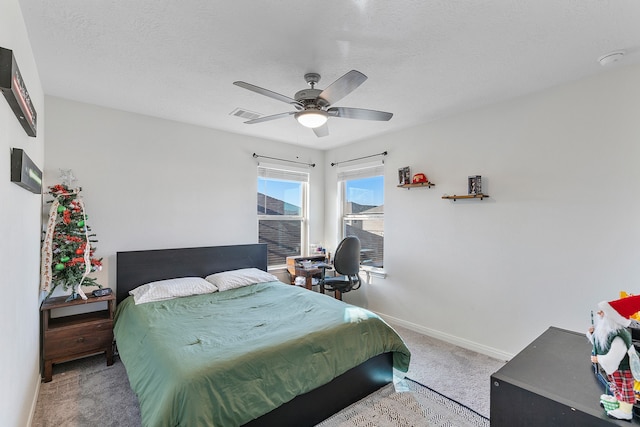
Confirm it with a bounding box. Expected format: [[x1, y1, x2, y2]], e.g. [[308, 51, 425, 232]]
[[326, 66, 640, 357]]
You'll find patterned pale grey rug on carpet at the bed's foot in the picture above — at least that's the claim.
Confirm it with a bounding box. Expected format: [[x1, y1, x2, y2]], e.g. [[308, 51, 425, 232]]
[[318, 378, 489, 427]]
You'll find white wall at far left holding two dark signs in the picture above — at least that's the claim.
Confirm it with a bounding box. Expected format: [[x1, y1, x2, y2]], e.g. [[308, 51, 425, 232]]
[[0, 0, 45, 426]]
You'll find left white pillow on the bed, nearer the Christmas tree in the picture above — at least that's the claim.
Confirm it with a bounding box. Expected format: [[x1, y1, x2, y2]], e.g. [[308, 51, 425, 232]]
[[129, 277, 218, 304]]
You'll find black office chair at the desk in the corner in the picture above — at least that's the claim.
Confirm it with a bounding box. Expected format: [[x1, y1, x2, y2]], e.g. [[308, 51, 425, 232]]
[[319, 236, 362, 300]]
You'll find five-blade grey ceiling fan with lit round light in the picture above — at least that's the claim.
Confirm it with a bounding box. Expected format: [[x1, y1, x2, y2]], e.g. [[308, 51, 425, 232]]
[[233, 70, 393, 137]]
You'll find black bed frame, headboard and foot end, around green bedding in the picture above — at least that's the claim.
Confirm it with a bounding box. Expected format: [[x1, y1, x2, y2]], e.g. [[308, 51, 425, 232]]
[[116, 244, 393, 427]]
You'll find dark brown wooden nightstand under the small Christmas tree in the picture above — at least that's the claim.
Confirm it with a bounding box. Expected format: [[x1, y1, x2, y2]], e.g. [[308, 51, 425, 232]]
[[40, 294, 116, 382]]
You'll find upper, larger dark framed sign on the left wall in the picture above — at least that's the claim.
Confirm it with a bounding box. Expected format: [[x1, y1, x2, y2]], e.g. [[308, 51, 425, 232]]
[[0, 47, 38, 136]]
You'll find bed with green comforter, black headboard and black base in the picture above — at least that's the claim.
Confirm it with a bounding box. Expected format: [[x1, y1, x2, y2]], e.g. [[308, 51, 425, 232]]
[[114, 244, 410, 427]]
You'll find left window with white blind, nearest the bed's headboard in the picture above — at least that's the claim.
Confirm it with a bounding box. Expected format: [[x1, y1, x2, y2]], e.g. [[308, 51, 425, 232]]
[[258, 166, 309, 267]]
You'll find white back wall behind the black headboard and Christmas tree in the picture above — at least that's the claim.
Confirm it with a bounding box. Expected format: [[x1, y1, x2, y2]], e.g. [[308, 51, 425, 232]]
[[45, 97, 324, 290]]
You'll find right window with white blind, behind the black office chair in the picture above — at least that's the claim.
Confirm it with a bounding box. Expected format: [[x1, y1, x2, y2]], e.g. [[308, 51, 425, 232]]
[[338, 165, 384, 268]]
